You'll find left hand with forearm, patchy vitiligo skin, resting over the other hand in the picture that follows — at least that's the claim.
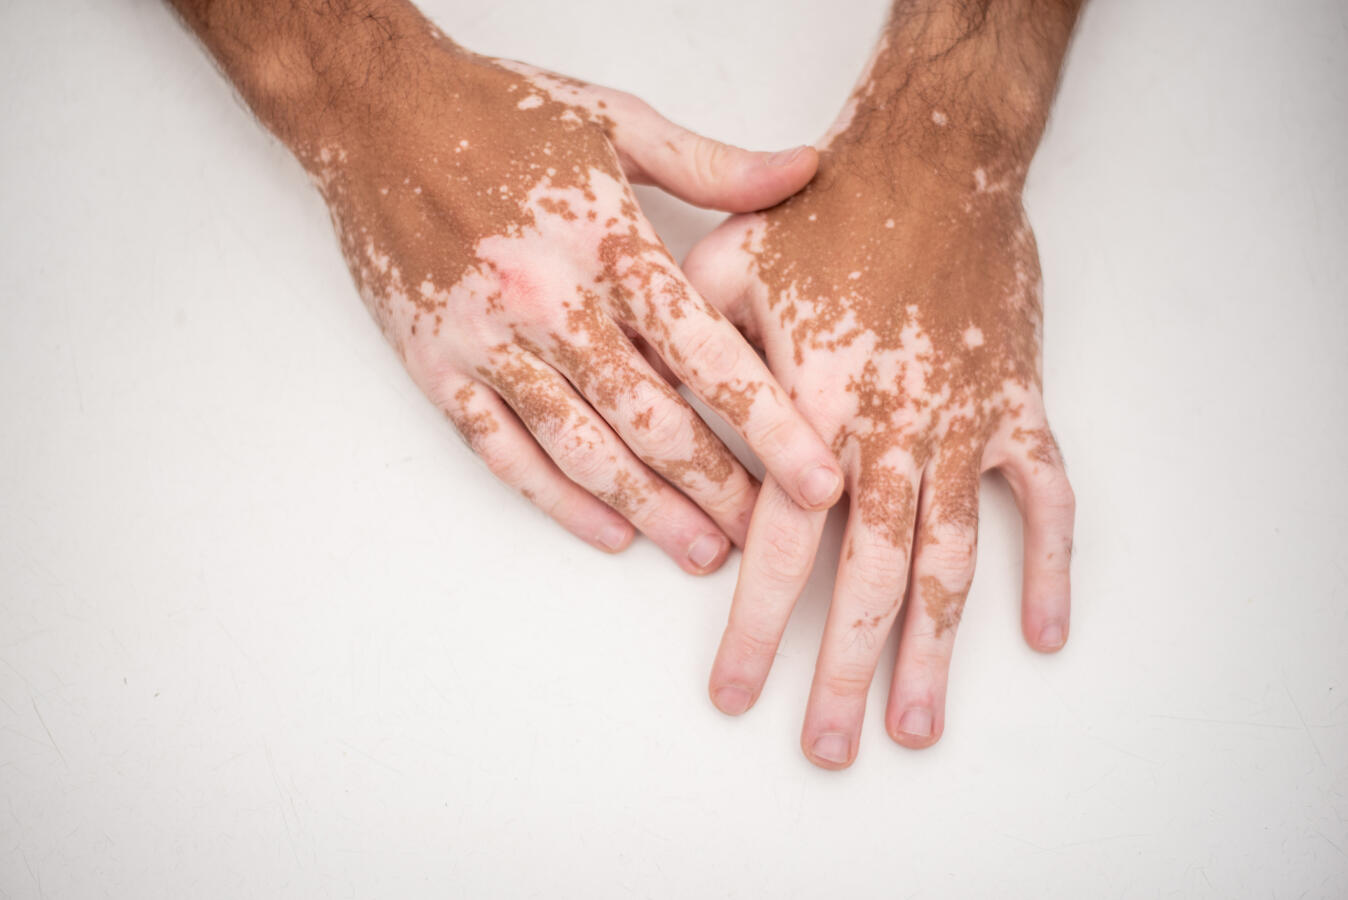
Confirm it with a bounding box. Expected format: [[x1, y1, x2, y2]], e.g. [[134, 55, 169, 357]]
[[173, 0, 843, 573]]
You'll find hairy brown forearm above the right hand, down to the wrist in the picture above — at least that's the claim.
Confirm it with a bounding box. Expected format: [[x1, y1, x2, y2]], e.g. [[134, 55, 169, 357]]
[[837, 0, 1082, 170]]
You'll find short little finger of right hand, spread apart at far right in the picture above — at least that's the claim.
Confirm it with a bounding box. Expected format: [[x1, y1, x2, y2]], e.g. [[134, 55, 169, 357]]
[[1000, 426, 1076, 653]]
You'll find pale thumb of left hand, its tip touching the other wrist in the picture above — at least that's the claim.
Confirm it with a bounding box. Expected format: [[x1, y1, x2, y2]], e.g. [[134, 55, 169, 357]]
[[613, 104, 820, 213]]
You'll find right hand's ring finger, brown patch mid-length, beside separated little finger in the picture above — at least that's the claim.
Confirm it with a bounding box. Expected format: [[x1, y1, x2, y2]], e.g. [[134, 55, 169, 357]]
[[884, 461, 979, 749]]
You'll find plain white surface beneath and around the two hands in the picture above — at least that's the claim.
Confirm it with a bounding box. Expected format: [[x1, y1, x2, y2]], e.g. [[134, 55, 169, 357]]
[[0, 0, 1348, 897]]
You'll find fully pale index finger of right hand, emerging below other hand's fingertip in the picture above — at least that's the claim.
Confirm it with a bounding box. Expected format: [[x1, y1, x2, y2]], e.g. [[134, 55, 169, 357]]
[[708, 477, 828, 715]]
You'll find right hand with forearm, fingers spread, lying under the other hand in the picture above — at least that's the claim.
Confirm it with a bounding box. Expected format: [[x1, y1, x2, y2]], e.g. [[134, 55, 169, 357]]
[[685, 0, 1078, 769]]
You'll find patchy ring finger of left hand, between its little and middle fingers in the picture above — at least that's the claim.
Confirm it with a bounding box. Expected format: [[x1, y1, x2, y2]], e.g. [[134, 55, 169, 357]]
[[479, 349, 729, 574]]
